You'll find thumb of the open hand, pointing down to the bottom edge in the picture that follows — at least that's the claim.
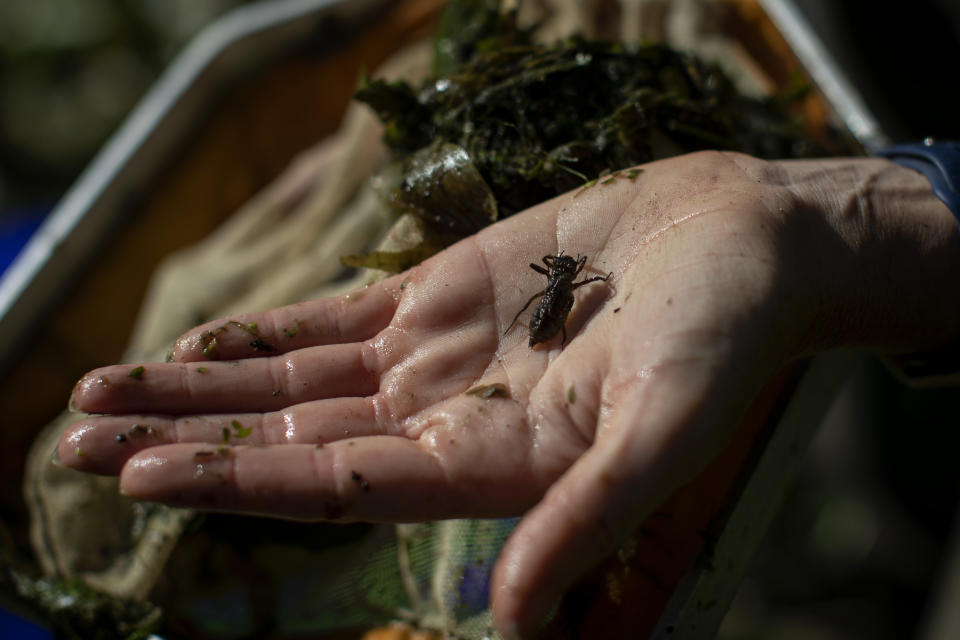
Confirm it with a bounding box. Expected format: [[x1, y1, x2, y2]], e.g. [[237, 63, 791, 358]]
[[491, 360, 750, 639]]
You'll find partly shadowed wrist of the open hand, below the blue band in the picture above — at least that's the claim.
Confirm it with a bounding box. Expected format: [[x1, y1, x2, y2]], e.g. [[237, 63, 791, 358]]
[[775, 158, 960, 352]]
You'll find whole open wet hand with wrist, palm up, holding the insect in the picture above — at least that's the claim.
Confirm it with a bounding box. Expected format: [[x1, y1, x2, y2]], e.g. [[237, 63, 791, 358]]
[[59, 152, 960, 638]]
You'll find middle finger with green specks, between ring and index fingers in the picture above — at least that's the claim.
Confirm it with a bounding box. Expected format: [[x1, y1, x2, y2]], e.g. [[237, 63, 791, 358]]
[[57, 397, 389, 475]]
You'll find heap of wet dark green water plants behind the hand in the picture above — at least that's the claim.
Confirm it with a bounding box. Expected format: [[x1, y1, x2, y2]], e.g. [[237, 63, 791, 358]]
[[343, 26, 813, 271]]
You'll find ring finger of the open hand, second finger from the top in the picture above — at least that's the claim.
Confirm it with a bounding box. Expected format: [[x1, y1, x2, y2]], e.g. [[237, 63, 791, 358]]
[[70, 343, 379, 414]]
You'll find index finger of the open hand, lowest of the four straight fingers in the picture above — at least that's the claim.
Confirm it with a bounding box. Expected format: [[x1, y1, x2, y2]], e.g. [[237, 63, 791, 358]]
[[120, 436, 490, 522]]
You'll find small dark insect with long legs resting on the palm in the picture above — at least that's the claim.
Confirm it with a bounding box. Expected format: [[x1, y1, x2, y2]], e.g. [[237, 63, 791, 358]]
[[503, 251, 613, 347]]
